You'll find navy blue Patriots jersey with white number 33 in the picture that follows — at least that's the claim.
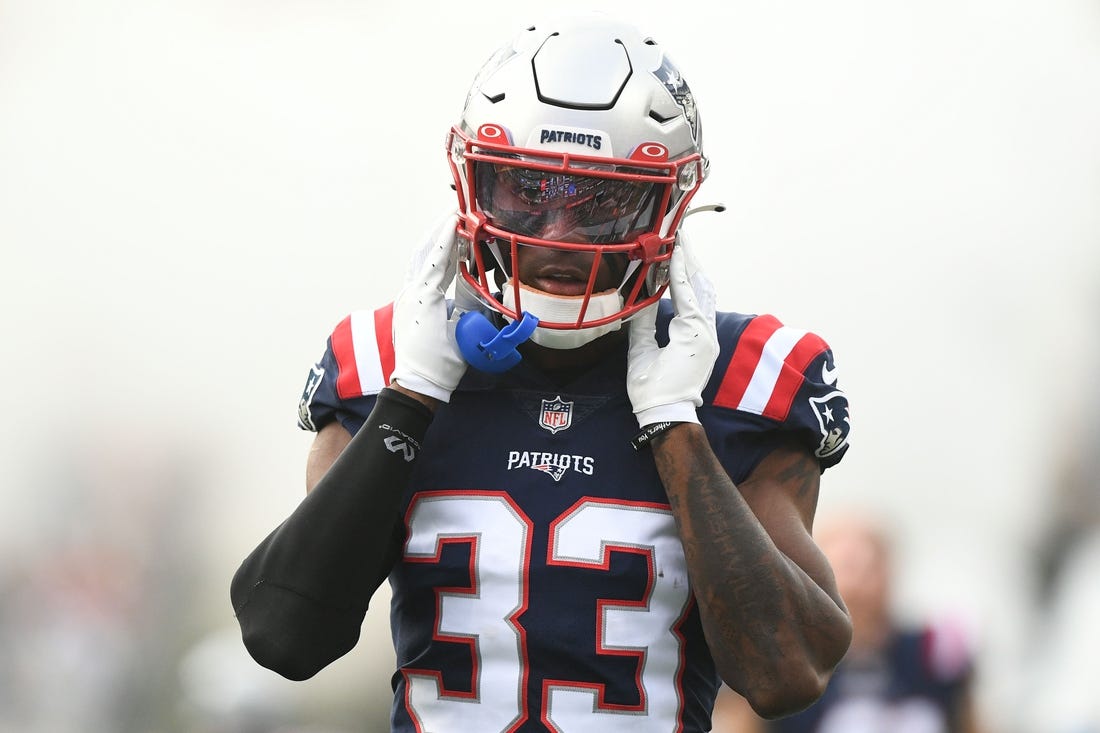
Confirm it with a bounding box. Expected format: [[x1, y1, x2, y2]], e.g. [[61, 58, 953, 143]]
[[298, 300, 848, 733]]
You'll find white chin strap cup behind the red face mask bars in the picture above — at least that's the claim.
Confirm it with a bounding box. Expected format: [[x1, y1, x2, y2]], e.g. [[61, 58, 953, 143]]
[[501, 280, 623, 349]]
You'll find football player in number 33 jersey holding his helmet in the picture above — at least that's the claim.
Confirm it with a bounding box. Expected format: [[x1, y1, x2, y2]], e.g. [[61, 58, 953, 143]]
[[231, 15, 851, 733]]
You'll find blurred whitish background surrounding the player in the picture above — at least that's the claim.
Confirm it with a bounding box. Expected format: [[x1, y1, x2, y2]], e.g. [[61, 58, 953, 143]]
[[0, 0, 1100, 733]]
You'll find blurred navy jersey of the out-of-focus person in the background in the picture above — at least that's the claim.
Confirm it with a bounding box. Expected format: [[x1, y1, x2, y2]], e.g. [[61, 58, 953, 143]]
[[767, 626, 972, 733]]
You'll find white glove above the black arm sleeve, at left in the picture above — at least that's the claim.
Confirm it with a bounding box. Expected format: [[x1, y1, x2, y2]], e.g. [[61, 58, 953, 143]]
[[391, 215, 466, 402]]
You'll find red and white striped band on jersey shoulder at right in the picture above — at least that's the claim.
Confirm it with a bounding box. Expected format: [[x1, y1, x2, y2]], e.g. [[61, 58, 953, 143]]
[[714, 316, 827, 419]]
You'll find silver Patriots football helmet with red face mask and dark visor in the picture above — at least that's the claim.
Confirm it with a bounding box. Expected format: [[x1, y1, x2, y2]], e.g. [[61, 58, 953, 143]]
[[448, 15, 707, 348]]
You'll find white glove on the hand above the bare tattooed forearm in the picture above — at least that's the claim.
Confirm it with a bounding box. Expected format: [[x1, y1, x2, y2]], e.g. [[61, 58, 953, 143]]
[[626, 232, 718, 427]]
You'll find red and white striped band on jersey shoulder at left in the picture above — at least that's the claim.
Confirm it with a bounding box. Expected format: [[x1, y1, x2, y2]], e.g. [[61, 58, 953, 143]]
[[332, 305, 394, 400]]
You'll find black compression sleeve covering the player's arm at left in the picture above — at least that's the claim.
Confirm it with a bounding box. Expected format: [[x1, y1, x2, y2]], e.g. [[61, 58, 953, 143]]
[[230, 389, 431, 680]]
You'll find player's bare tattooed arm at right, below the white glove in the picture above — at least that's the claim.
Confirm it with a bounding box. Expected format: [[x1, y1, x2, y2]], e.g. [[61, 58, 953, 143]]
[[653, 425, 850, 713]]
